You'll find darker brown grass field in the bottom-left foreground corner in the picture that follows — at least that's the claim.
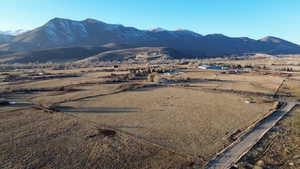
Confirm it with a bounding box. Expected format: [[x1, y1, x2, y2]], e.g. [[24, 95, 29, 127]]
[[0, 107, 191, 169]]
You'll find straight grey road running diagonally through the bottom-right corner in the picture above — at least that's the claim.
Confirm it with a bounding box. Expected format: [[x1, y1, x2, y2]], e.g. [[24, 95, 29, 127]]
[[207, 102, 299, 169]]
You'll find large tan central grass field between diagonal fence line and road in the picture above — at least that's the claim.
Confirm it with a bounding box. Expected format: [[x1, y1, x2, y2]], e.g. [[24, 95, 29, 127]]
[[59, 88, 271, 160]]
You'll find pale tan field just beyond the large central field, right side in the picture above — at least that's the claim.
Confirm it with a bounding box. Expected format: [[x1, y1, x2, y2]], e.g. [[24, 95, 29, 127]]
[[179, 70, 284, 94]]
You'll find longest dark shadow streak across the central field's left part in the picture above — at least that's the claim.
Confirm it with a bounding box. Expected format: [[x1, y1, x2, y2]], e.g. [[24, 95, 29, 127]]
[[56, 106, 140, 113]]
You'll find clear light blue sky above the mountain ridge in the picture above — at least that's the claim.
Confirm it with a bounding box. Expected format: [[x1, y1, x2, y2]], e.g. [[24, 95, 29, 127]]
[[0, 0, 300, 44]]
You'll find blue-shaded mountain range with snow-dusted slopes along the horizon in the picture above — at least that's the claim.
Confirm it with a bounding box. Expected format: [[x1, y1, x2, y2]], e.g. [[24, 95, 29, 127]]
[[0, 18, 300, 62]]
